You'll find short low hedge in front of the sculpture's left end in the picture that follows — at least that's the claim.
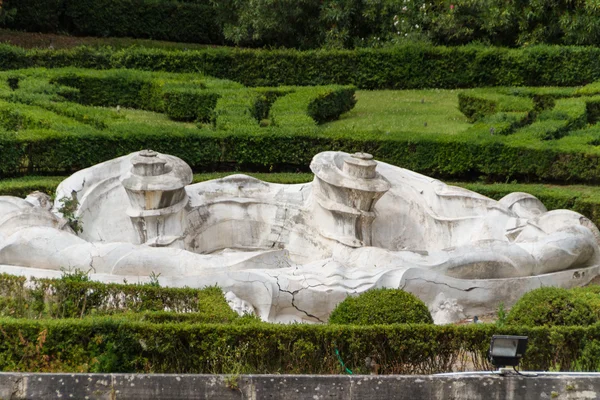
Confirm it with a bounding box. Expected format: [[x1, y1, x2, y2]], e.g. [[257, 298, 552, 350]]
[[0, 271, 238, 323]]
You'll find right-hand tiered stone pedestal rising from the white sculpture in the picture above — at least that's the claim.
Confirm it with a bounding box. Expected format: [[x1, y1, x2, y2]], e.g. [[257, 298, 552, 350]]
[[310, 153, 390, 247]]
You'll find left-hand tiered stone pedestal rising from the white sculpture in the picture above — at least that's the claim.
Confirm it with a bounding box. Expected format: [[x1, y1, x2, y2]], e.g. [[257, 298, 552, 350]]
[[121, 150, 192, 248]]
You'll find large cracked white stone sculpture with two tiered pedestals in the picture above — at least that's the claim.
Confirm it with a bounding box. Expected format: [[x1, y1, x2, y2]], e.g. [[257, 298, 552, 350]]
[[0, 151, 600, 323]]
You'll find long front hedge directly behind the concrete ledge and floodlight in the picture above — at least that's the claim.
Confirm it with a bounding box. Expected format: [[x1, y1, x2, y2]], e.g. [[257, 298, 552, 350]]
[[0, 317, 600, 374]]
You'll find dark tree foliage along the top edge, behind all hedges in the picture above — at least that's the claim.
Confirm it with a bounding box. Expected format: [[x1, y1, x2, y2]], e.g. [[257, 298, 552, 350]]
[[5, 0, 600, 48]]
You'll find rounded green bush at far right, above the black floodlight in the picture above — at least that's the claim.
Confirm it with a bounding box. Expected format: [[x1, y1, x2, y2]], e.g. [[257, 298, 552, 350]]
[[506, 287, 597, 326]]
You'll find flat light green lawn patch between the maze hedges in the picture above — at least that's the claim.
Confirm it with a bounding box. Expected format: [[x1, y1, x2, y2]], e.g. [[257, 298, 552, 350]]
[[323, 89, 471, 135]]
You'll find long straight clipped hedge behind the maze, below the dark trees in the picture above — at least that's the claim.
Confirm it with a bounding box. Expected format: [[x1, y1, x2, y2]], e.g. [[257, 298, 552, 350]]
[[8, 45, 600, 89]]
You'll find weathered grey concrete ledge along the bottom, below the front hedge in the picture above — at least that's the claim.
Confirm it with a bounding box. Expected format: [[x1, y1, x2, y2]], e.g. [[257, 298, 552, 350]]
[[0, 373, 600, 400]]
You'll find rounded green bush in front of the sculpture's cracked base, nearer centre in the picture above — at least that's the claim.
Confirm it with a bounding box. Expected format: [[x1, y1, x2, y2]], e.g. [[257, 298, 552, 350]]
[[329, 289, 433, 325]]
